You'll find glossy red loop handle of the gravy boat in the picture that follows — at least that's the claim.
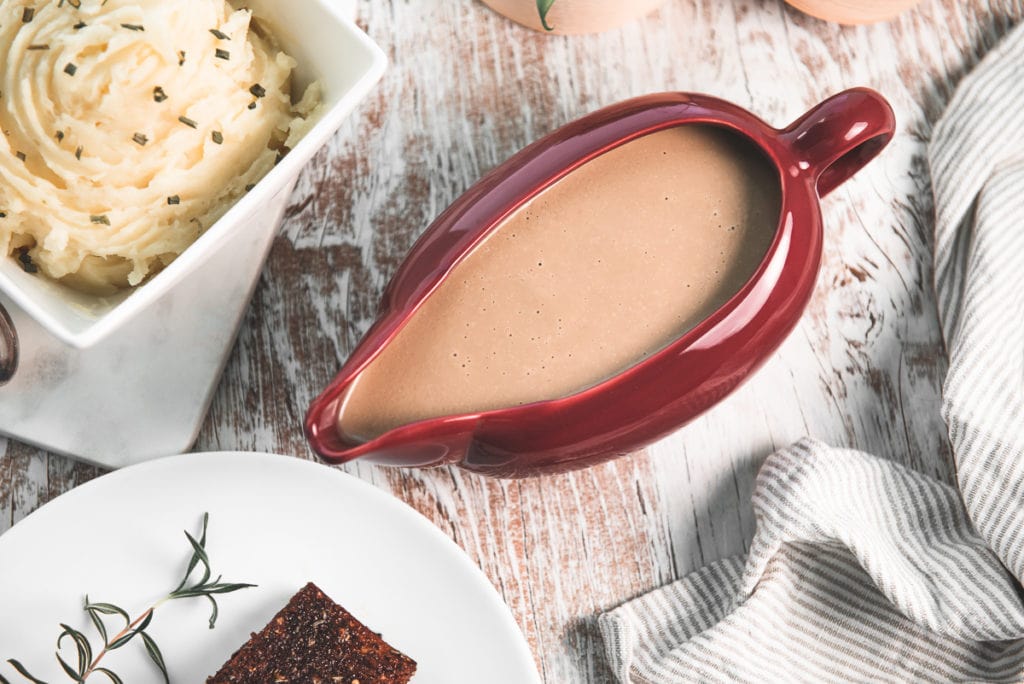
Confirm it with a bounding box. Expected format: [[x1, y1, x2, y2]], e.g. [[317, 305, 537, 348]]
[[782, 88, 896, 197]]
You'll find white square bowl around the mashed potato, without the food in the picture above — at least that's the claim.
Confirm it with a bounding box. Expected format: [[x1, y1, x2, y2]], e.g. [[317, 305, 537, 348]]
[[0, 0, 387, 349]]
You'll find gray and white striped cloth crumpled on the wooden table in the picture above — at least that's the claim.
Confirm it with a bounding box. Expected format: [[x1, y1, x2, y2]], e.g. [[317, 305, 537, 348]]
[[599, 21, 1024, 683]]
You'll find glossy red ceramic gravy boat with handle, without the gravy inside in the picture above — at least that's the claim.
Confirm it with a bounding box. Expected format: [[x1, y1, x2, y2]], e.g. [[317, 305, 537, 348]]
[[305, 88, 895, 477]]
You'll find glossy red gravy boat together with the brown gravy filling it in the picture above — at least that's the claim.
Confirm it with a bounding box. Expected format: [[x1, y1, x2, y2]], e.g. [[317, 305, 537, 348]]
[[305, 88, 895, 477]]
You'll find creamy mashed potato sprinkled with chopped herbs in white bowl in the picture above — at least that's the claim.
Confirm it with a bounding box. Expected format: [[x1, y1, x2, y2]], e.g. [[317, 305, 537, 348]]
[[0, 0, 319, 294]]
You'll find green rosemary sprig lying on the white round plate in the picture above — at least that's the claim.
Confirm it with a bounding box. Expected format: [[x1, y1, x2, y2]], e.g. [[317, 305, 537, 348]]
[[0, 513, 256, 684]]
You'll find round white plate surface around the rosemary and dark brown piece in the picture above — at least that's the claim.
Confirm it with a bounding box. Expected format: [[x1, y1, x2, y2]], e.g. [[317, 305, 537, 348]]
[[0, 453, 540, 684]]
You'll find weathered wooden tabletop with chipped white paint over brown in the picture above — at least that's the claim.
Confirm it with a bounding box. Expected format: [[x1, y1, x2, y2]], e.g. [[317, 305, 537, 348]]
[[0, 0, 1024, 682]]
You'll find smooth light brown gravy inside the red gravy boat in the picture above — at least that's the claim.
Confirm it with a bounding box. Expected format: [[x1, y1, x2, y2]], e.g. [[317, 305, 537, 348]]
[[338, 124, 780, 442]]
